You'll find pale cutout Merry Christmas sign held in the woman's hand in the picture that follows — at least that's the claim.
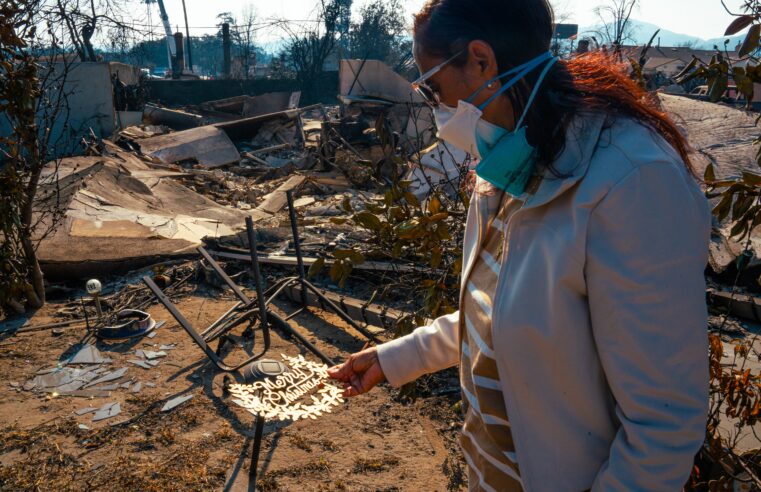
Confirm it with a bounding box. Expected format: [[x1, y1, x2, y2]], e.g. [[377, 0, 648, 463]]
[[228, 354, 344, 421]]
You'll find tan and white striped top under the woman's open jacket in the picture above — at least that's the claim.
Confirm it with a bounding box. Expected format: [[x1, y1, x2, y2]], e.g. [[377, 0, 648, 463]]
[[460, 194, 523, 492]]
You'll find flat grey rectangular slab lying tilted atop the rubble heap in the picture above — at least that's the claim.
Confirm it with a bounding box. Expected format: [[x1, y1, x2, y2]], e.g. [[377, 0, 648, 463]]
[[137, 125, 240, 168]]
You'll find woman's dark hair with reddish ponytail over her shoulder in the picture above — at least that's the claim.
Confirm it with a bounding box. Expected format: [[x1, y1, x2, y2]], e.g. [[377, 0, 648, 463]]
[[414, 0, 695, 175]]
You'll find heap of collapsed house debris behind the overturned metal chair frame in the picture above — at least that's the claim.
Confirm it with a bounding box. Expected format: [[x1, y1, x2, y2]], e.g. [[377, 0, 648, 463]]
[[29, 60, 470, 280]]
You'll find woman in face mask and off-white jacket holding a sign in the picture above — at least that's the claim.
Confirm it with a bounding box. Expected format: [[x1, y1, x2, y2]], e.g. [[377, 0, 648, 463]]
[[330, 0, 710, 492]]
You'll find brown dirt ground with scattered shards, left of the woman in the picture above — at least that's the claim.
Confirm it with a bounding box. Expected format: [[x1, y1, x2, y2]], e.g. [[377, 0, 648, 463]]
[[0, 294, 465, 491]]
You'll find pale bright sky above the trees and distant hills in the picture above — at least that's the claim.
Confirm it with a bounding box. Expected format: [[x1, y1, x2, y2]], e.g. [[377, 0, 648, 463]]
[[153, 0, 742, 42]]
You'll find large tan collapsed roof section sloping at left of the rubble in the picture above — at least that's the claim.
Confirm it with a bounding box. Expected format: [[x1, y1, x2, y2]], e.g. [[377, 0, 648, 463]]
[[39, 149, 246, 278]]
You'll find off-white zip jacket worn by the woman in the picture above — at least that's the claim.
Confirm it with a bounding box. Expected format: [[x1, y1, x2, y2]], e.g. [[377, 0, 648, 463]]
[[378, 115, 711, 492]]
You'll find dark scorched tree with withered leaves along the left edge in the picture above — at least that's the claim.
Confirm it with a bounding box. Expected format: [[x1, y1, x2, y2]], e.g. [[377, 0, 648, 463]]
[[0, 0, 54, 312]]
